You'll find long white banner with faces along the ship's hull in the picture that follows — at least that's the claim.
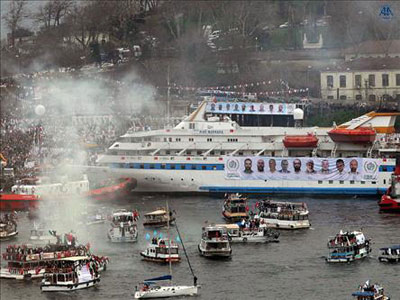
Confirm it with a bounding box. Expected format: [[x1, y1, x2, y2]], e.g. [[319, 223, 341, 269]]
[[225, 156, 379, 181]]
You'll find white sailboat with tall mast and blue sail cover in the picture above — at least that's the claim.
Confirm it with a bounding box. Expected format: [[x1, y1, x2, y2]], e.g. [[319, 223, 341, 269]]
[[134, 203, 199, 299]]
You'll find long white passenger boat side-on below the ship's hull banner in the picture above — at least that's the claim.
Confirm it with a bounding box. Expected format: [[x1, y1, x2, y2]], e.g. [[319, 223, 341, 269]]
[[257, 200, 311, 230]]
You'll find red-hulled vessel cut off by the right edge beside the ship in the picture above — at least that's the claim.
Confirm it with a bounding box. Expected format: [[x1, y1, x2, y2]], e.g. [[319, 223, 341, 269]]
[[378, 156, 400, 213]]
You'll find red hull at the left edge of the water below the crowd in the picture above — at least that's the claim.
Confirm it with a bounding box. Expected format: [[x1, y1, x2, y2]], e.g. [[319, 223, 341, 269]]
[[0, 194, 40, 211]]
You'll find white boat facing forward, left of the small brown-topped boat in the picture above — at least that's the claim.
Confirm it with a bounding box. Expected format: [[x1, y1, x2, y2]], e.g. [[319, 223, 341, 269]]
[[108, 209, 138, 243]]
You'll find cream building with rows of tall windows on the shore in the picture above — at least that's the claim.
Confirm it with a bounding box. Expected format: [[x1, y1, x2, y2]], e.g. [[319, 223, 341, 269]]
[[321, 58, 400, 102]]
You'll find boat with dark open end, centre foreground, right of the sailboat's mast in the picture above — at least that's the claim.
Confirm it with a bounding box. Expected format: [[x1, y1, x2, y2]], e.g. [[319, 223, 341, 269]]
[[198, 225, 232, 258]]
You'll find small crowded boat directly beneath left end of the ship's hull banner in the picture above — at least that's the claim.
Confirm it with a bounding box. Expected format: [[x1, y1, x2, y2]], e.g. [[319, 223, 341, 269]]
[[222, 194, 249, 222]]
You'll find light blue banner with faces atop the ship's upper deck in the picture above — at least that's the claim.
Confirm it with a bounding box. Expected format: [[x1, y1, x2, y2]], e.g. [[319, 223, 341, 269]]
[[206, 102, 295, 115]]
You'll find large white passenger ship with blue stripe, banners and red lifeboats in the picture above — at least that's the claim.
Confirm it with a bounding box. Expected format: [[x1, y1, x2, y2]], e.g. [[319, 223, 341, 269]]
[[98, 101, 400, 195]]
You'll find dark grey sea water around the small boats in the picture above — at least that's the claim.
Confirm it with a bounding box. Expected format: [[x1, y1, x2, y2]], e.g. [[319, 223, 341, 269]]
[[0, 196, 400, 300]]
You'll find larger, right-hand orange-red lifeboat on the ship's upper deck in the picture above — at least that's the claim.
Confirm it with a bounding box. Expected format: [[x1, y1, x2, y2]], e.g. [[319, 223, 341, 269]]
[[328, 127, 376, 144]]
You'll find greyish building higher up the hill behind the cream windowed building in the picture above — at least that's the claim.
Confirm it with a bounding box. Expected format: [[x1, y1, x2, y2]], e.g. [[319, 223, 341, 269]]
[[344, 40, 400, 61]]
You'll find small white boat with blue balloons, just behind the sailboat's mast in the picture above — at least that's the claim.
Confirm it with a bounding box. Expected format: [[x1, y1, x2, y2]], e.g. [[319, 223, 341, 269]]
[[140, 237, 181, 263]]
